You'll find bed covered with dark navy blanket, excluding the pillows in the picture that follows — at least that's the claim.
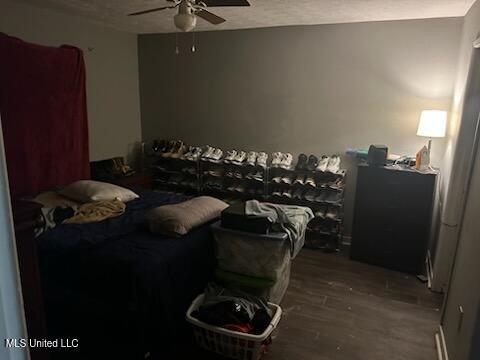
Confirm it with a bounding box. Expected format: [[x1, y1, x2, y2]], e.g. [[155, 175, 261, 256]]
[[38, 189, 215, 359]]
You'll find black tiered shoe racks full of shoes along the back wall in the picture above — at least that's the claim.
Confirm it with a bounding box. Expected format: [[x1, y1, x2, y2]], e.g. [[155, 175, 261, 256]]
[[151, 153, 346, 251]]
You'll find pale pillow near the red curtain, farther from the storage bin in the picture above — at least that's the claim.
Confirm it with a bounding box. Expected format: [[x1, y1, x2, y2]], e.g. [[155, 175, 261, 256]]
[[59, 180, 138, 203]]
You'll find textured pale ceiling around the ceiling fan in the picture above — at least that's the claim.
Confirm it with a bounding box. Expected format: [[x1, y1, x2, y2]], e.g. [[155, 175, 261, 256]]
[[18, 0, 475, 33]]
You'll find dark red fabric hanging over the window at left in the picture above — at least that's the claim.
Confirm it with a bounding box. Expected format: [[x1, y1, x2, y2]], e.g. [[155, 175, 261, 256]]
[[0, 33, 90, 197]]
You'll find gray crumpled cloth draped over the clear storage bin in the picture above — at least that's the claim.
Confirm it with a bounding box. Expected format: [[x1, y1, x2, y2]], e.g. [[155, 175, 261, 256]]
[[245, 200, 314, 259]]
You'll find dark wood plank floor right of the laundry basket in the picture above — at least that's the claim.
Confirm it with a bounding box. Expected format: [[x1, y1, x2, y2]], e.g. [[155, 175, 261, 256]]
[[265, 249, 442, 360]]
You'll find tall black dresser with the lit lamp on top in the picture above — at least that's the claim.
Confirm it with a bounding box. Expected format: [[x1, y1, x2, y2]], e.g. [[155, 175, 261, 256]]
[[350, 165, 437, 274]]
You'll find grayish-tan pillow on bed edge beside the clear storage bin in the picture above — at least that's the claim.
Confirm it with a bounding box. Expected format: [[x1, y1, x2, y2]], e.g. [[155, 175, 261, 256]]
[[146, 196, 228, 236]]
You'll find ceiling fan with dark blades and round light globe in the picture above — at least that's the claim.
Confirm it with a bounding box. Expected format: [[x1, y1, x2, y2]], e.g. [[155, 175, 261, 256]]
[[128, 0, 250, 31]]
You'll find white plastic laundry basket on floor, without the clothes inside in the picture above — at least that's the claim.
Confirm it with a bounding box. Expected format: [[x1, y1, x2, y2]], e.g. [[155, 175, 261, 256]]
[[186, 294, 282, 360]]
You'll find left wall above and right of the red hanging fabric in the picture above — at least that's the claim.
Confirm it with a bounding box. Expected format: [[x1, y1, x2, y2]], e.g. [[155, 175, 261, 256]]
[[0, 0, 141, 160]]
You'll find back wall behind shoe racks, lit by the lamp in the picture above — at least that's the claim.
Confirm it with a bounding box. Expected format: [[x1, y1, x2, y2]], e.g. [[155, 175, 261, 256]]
[[139, 18, 462, 235]]
